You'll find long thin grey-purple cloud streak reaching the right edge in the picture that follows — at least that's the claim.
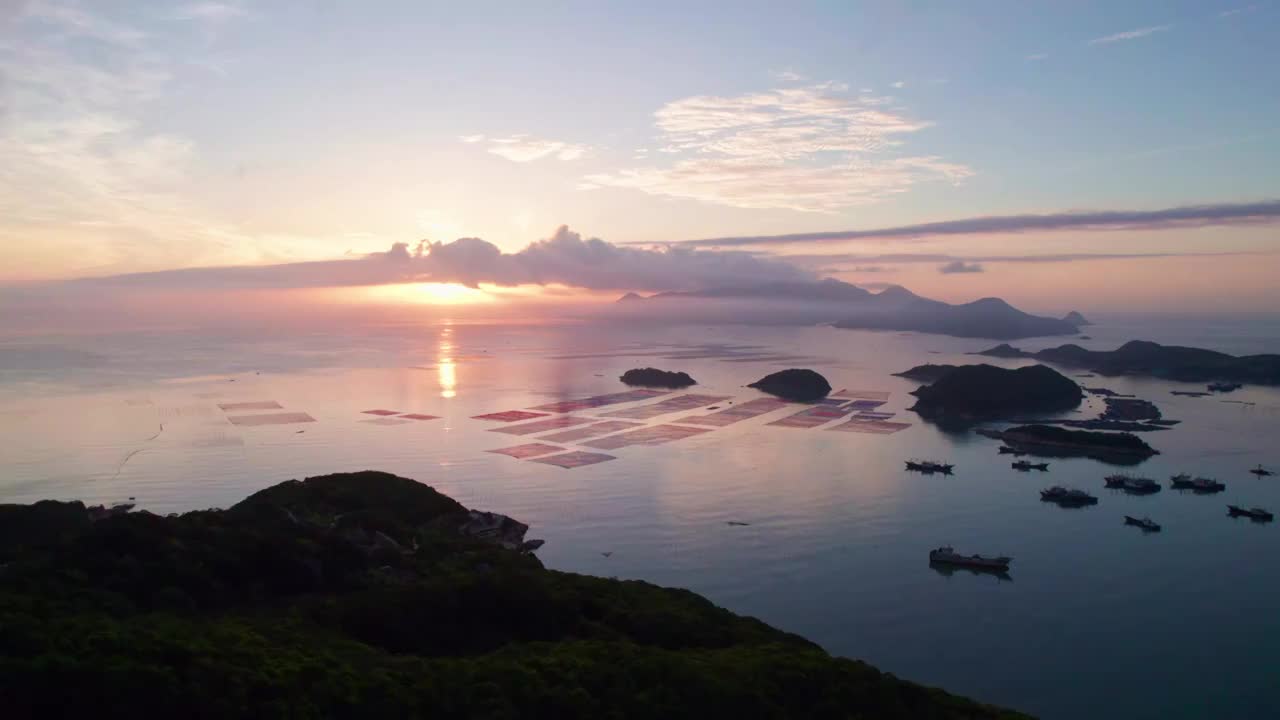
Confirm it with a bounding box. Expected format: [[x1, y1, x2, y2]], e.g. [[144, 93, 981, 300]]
[[665, 200, 1280, 247]]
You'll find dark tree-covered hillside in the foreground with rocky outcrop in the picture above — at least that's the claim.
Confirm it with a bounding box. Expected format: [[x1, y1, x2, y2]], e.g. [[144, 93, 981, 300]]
[[0, 471, 1025, 720]]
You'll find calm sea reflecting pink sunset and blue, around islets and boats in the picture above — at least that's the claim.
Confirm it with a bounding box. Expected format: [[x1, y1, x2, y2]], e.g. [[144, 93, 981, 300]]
[[0, 316, 1280, 720]]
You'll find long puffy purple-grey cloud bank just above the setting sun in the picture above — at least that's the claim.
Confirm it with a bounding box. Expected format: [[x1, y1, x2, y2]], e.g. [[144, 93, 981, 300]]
[[69, 227, 814, 292]]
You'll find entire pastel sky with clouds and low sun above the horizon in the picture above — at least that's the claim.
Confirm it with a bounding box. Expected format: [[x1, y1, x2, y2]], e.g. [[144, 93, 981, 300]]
[[0, 0, 1280, 311]]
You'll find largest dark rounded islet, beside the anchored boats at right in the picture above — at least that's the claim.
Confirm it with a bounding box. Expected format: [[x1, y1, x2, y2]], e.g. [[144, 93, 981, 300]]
[[900, 365, 1084, 419]]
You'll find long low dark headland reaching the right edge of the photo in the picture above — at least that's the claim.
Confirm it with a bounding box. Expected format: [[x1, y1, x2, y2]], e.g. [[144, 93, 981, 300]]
[[977, 340, 1280, 384]]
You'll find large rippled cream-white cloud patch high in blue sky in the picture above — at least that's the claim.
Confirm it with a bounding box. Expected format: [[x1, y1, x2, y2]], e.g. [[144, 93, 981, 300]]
[[582, 83, 973, 213]]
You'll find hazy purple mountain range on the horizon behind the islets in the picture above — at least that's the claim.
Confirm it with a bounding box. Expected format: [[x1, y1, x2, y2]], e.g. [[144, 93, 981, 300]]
[[618, 279, 1087, 340]]
